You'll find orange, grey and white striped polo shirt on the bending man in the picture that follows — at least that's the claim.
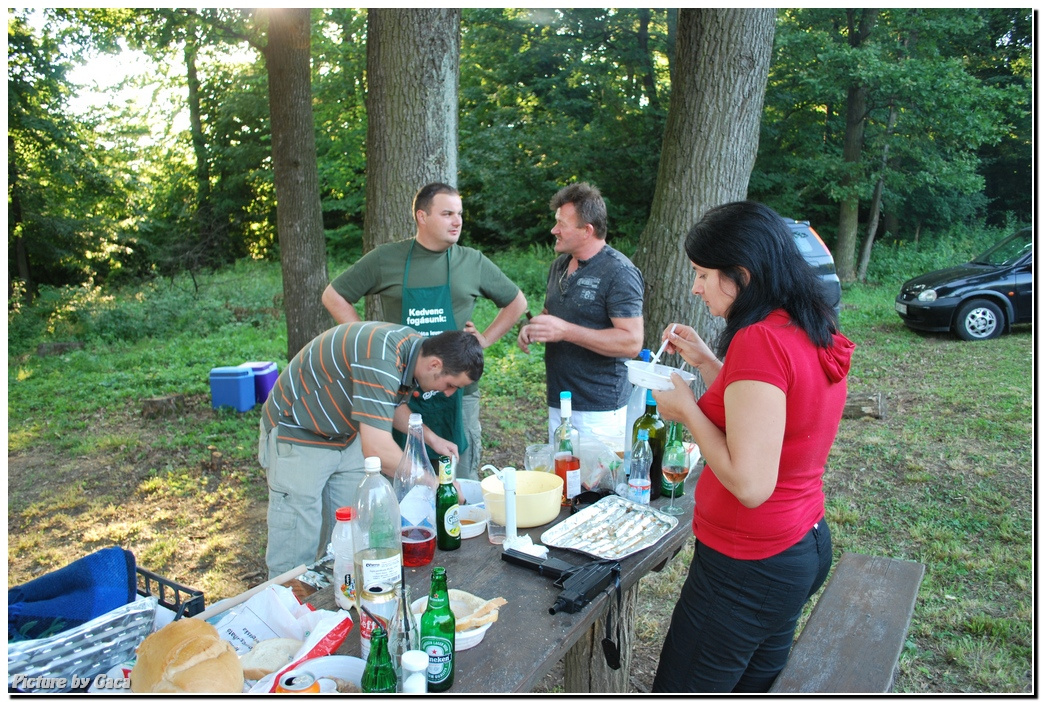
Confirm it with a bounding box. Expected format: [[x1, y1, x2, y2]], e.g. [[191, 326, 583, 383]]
[[260, 322, 423, 449]]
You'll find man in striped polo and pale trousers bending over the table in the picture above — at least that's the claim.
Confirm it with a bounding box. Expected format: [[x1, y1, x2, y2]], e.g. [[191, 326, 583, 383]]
[[264, 322, 484, 578]]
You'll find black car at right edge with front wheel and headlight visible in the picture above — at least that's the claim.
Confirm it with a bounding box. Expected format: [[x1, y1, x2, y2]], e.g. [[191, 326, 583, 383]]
[[896, 227, 1034, 342]]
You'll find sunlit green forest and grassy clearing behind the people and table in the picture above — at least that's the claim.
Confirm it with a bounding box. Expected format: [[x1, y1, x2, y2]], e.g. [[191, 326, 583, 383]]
[[7, 8, 1036, 693]]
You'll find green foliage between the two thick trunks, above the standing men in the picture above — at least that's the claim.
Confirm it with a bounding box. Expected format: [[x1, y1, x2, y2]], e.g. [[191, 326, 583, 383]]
[[459, 8, 668, 248]]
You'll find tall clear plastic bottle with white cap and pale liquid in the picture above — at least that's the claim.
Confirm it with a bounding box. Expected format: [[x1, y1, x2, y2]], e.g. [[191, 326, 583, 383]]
[[351, 456, 402, 657]]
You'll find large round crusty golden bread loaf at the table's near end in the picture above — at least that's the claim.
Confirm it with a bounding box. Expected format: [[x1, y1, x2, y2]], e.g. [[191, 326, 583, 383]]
[[130, 619, 245, 693]]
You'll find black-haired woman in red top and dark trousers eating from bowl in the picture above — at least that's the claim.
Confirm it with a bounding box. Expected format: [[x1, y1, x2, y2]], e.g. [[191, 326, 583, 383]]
[[653, 201, 854, 693]]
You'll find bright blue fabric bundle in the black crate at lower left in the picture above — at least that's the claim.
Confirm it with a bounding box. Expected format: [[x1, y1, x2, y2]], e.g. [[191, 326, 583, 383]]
[[7, 546, 137, 642]]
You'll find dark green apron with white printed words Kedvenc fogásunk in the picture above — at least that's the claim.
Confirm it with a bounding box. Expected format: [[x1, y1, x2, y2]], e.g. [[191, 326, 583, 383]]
[[393, 241, 468, 458]]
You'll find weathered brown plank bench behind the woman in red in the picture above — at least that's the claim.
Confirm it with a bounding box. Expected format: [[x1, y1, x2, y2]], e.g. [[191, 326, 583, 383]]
[[770, 553, 925, 693]]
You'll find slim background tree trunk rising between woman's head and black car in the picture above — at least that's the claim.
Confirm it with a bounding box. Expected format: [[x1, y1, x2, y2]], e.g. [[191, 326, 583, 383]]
[[835, 9, 879, 280]]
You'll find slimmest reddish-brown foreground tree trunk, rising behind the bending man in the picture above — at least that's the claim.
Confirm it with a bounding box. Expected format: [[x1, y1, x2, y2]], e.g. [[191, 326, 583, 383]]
[[264, 8, 329, 358]]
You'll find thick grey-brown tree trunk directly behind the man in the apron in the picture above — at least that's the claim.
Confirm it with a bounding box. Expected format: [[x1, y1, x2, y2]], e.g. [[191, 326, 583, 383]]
[[362, 8, 461, 322]]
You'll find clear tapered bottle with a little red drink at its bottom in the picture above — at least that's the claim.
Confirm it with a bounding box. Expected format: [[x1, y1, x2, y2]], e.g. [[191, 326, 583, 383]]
[[393, 412, 437, 568]]
